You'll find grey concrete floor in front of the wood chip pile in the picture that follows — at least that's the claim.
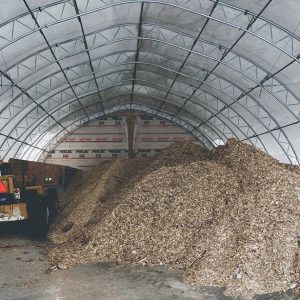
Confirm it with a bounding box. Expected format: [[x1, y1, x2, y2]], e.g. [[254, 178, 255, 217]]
[[0, 234, 297, 300]]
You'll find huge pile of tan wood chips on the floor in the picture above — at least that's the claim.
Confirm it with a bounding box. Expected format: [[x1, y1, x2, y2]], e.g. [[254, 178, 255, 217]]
[[49, 140, 300, 295]]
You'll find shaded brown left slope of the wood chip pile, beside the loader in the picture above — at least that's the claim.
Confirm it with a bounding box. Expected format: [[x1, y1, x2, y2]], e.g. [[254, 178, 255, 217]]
[[51, 159, 149, 246]]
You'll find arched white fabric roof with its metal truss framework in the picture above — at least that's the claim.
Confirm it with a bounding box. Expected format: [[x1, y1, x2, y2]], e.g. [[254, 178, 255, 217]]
[[0, 0, 300, 164]]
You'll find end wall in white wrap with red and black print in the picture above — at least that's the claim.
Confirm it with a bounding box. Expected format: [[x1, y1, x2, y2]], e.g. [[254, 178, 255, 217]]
[[45, 114, 197, 170]]
